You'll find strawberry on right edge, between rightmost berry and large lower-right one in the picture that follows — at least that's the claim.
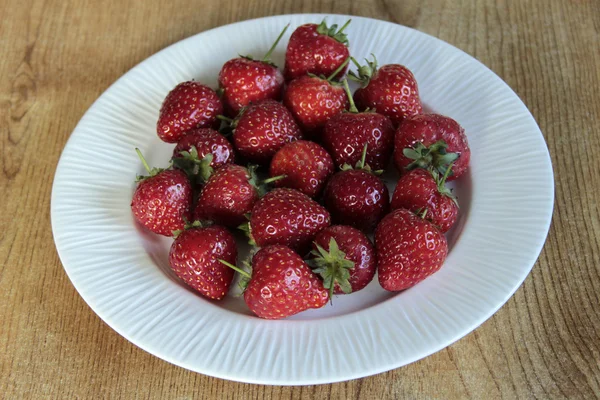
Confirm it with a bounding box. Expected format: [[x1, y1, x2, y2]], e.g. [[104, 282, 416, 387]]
[[391, 168, 458, 233]]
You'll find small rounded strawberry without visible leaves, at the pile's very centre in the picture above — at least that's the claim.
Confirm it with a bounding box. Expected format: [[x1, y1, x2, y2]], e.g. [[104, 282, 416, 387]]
[[269, 140, 333, 198]]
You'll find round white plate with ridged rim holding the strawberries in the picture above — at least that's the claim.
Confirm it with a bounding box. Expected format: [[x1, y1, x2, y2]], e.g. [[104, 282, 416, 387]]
[[52, 15, 554, 385]]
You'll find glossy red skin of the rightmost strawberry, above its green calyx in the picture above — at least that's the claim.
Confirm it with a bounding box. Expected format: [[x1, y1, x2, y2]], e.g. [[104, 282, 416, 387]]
[[394, 114, 471, 181]]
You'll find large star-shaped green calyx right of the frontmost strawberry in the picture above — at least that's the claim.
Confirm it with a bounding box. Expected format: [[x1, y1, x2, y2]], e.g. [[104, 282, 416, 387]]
[[307, 238, 354, 300]]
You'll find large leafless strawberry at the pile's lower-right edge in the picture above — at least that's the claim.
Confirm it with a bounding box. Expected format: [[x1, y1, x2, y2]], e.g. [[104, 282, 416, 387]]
[[375, 208, 448, 291]]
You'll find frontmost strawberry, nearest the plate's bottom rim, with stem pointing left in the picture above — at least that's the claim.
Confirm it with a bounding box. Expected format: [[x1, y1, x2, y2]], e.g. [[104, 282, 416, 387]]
[[222, 245, 329, 319]]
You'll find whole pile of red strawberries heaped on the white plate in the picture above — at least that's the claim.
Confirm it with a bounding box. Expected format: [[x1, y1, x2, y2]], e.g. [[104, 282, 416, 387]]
[[131, 21, 470, 319]]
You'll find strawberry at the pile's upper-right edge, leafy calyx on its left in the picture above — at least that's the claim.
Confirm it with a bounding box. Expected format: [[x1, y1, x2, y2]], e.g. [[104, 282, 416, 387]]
[[350, 56, 423, 125]]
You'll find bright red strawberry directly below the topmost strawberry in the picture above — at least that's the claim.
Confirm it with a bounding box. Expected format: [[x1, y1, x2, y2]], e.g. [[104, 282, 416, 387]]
[[283, 75, 348, 139]]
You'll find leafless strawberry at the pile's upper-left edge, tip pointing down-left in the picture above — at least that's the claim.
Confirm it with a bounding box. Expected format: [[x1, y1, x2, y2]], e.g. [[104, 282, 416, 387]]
[[156, 81, 223, 143]]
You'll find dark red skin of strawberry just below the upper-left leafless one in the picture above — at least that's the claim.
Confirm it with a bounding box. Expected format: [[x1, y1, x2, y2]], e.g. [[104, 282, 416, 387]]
[[173, 128, 235, 169]]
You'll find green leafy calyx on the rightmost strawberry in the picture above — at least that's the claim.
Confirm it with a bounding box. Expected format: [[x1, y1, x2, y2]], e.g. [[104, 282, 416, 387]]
[[402, 140, 458, 176]]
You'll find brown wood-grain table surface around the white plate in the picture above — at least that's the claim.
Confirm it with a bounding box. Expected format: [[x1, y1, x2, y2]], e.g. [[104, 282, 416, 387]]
[[0, 0, 600, 399]]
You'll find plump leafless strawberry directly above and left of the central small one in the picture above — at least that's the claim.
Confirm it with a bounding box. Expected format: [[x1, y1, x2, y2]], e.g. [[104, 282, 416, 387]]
[[233, 100, 302, 164]]
